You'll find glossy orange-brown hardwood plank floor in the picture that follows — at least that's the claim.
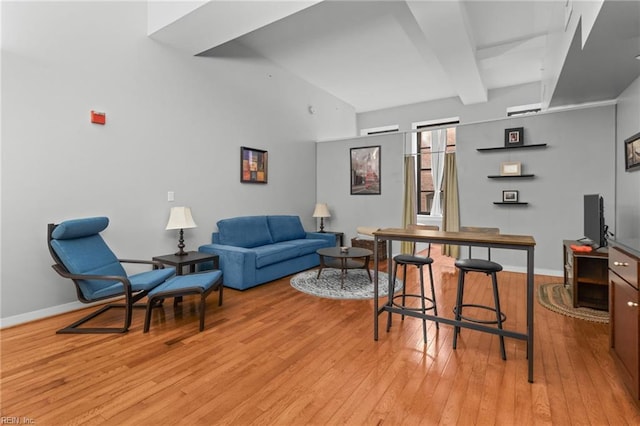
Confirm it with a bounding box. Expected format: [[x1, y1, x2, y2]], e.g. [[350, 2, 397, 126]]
[[1, 248, 640, 425]]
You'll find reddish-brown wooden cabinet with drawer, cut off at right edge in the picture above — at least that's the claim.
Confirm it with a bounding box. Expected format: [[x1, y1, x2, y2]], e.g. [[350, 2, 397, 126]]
[[609, 247, 640, 400]]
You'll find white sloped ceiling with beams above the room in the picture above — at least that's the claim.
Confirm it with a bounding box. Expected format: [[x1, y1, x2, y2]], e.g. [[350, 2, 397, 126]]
[[156, 0, 640, 112]]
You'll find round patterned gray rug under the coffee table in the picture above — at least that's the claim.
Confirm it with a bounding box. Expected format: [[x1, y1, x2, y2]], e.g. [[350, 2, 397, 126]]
[[291, 269, 402, 299]]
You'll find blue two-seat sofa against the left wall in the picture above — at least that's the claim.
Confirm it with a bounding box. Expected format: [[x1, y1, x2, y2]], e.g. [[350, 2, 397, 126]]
[[198, 215, 336, 290]]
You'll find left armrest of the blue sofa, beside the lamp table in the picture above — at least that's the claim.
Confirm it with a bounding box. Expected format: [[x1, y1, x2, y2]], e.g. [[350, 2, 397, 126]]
[[198, 244, 256, 288]]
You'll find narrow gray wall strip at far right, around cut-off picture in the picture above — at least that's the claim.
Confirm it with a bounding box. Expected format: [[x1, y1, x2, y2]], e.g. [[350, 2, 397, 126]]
[[615, 78, 640, 246]]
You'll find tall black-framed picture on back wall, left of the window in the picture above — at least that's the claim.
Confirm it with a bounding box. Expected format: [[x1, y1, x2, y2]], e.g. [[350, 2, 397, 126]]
[[351, 145, 381, 195]]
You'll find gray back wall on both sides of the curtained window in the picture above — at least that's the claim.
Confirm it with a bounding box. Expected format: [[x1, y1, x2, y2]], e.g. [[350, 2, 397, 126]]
[[318, 104, 615, 276]]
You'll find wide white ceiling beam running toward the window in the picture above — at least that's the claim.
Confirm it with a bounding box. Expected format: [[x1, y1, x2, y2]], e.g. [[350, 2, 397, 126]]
[[406, 0, 487, 105]]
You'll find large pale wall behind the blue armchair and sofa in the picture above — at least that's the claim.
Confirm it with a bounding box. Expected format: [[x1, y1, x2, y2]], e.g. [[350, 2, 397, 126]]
[[0, 2, 356, 326]]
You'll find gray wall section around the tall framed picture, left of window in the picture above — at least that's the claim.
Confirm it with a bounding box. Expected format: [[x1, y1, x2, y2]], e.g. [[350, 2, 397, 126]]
[[316, 133, 404, 245]]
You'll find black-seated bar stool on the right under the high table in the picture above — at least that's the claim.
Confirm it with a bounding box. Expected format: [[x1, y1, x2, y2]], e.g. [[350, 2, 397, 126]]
[[453, 227, 507, 360]]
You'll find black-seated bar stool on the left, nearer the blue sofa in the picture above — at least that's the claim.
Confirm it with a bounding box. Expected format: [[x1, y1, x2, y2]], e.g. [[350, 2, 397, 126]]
[[387, 225, 440, 343]]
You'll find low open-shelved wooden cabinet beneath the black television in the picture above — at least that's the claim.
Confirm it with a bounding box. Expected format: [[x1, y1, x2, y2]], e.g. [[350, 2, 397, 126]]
[[563, 240, 609, 311]]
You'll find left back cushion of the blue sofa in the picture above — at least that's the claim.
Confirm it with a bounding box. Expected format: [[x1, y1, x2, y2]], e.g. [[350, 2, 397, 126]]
[[217, 216, 273, 248]]
